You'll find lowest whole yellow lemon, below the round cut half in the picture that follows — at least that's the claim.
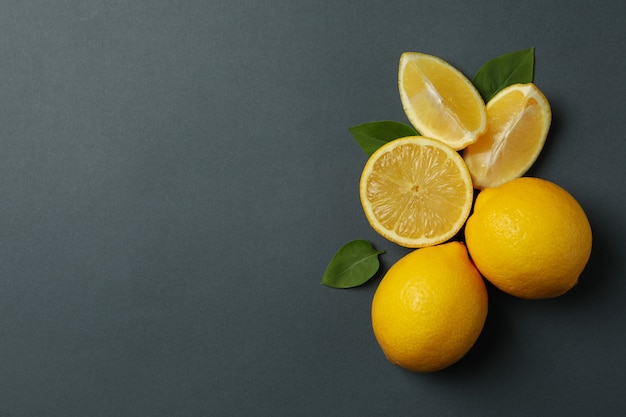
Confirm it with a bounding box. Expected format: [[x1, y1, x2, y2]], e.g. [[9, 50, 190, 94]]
[[371, 242, 487, 372]]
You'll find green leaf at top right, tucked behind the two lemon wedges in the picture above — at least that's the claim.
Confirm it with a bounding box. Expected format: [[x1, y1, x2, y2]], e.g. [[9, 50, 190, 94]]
[[473, 48, 535, 103]]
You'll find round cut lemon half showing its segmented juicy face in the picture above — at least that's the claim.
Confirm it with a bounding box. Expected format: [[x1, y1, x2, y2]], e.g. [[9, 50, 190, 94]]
[[359, 136, 474, 248]]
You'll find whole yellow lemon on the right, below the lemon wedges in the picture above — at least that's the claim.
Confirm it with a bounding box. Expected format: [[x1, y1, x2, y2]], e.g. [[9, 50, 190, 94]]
[[465, 177, 592, 299]]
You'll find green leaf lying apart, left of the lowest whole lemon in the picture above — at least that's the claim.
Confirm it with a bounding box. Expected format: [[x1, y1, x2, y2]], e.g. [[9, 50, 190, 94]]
[[322, 240, 385, 288]]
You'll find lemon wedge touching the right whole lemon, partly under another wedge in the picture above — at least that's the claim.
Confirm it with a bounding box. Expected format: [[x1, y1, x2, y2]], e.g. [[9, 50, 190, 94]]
[[463, 83, 552, 189]]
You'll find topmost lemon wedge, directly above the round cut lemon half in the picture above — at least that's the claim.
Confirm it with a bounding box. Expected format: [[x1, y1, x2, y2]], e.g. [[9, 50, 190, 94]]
[[398, 52, 487, 150]]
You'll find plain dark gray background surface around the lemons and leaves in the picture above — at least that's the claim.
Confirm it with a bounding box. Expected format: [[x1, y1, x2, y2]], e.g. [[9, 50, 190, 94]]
[[0, 0, 626, 417]]
